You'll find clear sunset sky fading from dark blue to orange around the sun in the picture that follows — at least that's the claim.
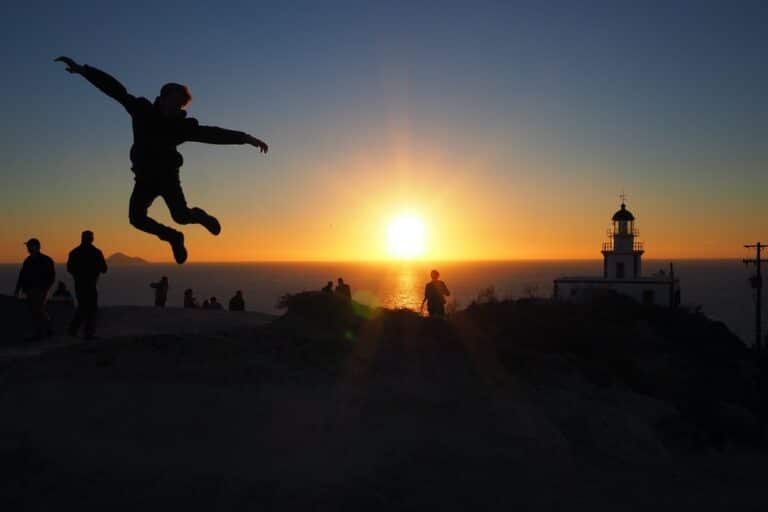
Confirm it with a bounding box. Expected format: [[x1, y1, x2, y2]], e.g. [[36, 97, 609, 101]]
[[0, 1, 768, 262]]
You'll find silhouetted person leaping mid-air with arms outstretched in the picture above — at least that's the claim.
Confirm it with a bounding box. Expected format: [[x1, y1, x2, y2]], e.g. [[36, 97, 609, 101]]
[[55, 57, 269, 263]]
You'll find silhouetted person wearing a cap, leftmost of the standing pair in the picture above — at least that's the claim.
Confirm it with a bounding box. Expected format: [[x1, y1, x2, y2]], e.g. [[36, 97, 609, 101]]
[[13, 238, 56, 339]]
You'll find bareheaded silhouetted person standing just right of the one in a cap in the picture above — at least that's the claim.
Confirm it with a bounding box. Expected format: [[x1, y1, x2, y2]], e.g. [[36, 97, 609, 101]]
[[67, 231, 107, 339]]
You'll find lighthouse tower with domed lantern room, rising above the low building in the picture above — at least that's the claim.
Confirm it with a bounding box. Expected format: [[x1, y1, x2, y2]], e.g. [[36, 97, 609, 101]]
[[603, 200, 645, 279]]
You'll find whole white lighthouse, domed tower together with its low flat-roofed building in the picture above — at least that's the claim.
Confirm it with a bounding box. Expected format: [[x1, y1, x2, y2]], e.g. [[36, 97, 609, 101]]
[[554, 196, 680, 307]]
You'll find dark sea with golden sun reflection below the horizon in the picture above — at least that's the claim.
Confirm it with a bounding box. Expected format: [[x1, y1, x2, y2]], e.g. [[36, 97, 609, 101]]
[[0, 259, 756, 344]]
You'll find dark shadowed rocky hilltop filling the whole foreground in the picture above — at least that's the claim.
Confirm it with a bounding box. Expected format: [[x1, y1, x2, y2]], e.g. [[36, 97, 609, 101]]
[[0, 296, 767, 511]]
